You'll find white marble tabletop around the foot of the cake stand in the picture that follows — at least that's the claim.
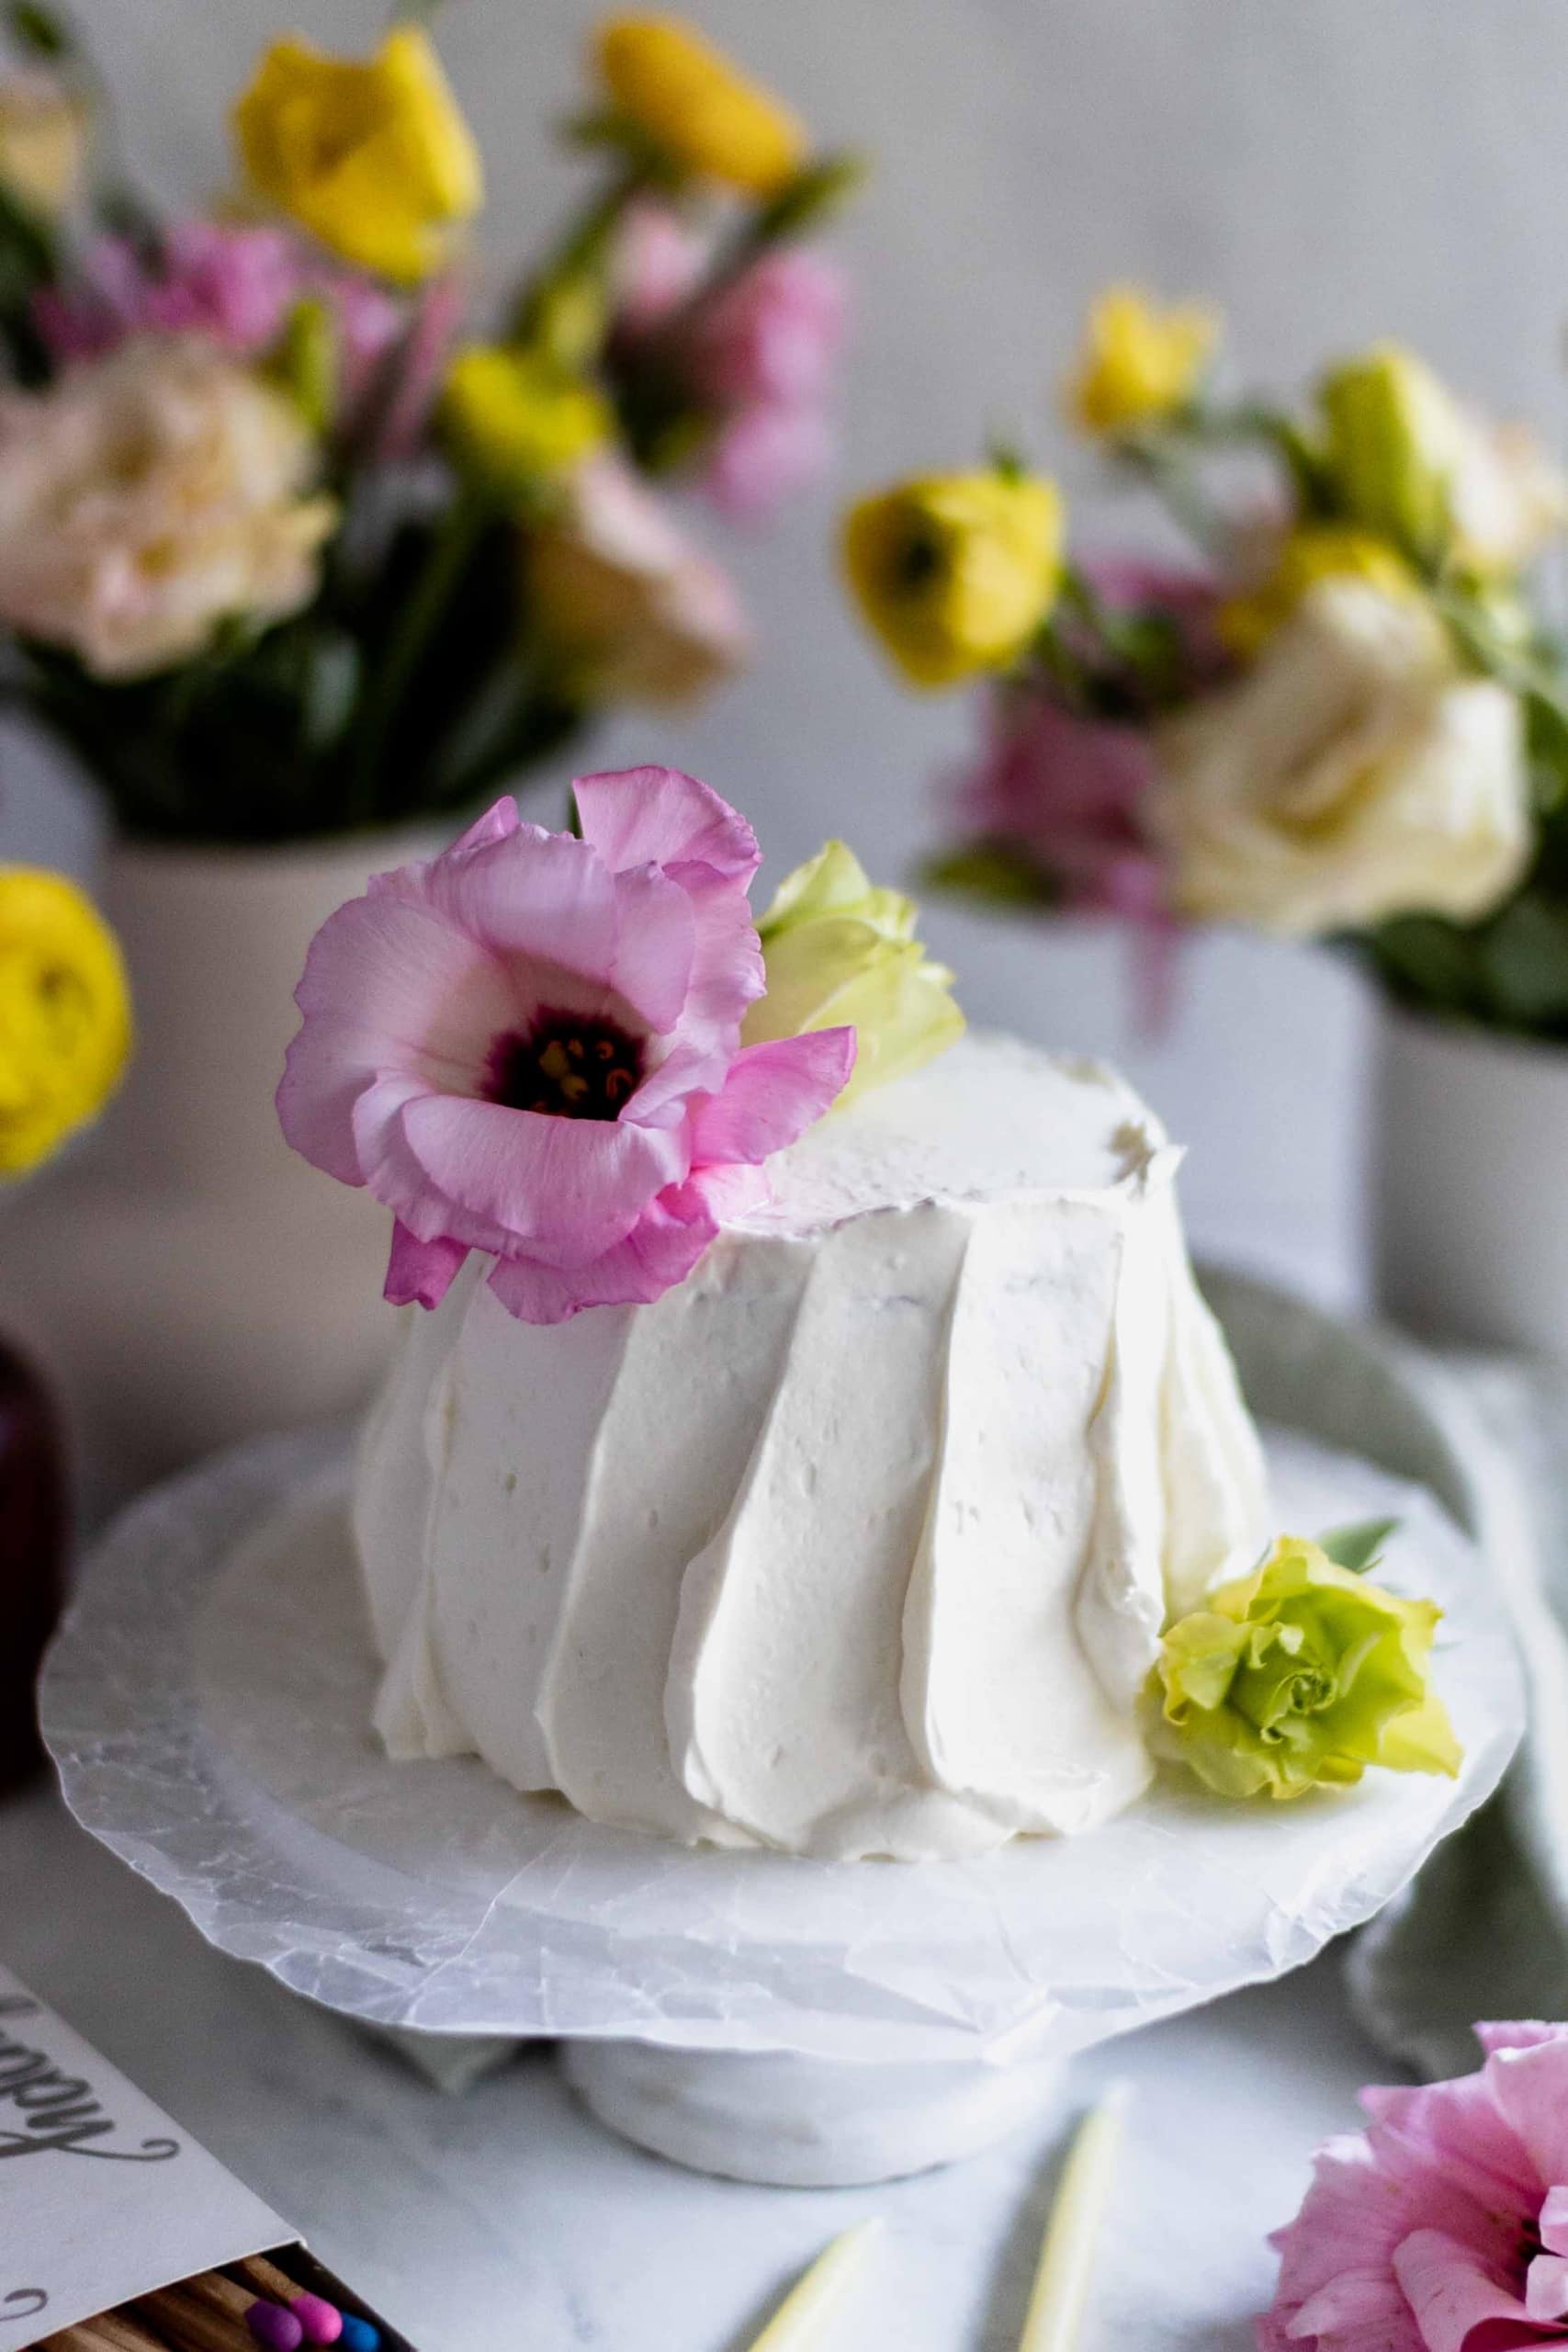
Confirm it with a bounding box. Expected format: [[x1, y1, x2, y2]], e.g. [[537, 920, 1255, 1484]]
[[0, 1788, 1380, 2352]]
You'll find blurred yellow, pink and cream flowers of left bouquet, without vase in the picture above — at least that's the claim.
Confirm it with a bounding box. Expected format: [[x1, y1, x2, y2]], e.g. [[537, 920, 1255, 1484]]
[[0, 0, 856, 842]]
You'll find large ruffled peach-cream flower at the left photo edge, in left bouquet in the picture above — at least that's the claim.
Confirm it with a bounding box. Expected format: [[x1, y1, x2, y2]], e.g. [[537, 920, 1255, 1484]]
[[0, 336, 336, 677]]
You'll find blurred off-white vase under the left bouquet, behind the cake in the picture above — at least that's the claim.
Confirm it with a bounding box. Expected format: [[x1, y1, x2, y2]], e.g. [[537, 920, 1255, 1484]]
[[0, 831, 434, 1494]]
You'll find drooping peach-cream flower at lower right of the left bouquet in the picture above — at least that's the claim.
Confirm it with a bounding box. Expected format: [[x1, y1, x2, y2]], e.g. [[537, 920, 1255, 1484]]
[[526, 452, 750, 703]]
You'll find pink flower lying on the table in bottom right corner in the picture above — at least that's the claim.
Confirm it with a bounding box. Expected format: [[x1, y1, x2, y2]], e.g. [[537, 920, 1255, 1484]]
[[1258, 2025, 1568, 2352]]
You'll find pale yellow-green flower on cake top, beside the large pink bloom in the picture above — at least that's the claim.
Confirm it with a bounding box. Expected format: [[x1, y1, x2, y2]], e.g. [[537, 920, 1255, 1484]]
[[740, 842, 964, 1103]]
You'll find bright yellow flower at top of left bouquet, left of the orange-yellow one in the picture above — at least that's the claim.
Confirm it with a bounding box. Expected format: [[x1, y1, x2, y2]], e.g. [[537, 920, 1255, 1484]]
[[232, 24, 482, 282]]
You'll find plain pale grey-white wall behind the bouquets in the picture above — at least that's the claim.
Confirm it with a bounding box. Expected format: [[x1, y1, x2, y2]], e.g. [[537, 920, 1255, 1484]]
[[12, 0, 1568, 1291]]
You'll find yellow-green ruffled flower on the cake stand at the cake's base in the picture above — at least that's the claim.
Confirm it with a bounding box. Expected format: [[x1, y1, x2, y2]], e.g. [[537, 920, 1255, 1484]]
[[1149, 1536, 1462, 1797]]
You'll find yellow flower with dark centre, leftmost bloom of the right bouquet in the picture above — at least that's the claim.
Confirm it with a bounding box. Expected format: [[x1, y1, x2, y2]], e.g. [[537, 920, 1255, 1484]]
[[841, 473, 1063, 687]]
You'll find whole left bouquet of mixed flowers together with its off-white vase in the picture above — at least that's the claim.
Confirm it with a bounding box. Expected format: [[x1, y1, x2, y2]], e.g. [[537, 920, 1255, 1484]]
[[0, 7, 856, 1475]]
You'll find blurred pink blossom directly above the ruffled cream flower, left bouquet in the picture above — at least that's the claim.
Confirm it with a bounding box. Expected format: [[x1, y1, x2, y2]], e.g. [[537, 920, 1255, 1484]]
[[35, 221, 402, 400]]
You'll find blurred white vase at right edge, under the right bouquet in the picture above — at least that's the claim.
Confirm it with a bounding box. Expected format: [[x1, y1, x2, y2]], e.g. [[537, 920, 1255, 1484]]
[[1373, 1007, 1568, 1364]]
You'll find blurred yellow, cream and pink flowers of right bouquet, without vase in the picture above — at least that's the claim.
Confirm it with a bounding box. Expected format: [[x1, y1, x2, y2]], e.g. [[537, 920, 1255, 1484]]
[[844, 287, 1568, 1040]]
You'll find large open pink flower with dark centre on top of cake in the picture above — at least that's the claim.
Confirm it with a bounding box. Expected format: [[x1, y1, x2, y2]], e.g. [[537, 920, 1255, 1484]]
[[277, 767, 856, 1324]]
